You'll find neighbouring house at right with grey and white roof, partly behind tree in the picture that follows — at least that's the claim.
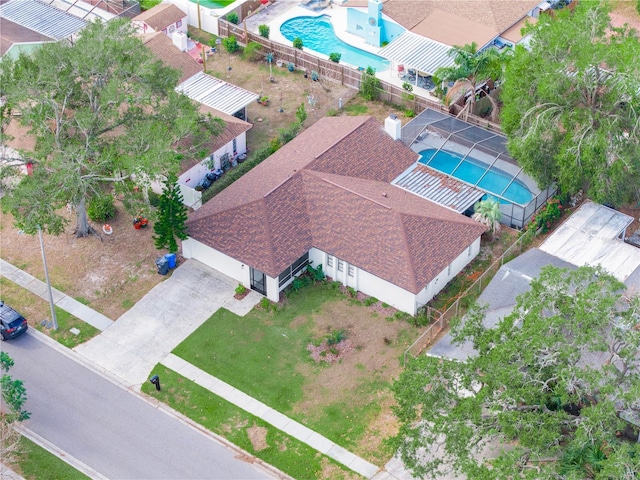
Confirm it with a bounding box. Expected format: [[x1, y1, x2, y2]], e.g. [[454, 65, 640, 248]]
[[428, 202, 640, 360]]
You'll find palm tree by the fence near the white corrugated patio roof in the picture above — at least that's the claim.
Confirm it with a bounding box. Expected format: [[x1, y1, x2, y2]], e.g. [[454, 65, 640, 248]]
[[433, 42, 505, 121]]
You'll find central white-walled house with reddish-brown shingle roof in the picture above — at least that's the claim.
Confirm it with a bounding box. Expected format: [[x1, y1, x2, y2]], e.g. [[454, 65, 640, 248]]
[[182, 117, 485, 314]]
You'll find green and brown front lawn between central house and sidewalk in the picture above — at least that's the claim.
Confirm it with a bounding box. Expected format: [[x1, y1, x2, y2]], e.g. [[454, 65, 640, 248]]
[[173, 284, 419, 466]]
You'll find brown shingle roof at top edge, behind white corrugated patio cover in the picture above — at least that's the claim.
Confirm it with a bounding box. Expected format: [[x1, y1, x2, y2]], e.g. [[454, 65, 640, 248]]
[[344, 0, 541, 41]]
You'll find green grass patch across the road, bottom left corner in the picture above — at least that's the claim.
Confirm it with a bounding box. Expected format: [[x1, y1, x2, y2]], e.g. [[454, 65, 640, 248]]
[[18, 437, 89, 480]]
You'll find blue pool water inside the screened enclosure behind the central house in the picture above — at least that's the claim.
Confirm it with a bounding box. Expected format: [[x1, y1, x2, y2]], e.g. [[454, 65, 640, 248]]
[[420, 148, 533, 205]]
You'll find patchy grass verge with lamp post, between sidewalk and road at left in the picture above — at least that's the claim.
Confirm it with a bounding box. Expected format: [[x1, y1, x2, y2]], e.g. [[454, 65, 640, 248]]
[[0, 278, 100, 348]]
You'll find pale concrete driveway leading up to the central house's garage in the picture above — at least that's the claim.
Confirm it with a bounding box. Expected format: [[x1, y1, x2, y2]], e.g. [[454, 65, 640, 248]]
[[75, 260, 261, 387]]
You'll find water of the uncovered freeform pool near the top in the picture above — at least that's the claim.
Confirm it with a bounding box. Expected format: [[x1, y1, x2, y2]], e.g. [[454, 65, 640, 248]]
[[280, 15, 390, 72]]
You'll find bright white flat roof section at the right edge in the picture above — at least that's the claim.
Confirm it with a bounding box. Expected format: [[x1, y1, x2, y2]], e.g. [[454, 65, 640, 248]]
[[540, 202, 640, 282]]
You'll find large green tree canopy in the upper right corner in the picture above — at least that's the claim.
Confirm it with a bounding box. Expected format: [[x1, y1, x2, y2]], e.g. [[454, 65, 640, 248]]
[[501, 2, 640, 205]]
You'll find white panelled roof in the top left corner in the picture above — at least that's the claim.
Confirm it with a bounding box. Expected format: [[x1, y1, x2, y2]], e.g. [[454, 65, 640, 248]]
[[0, 0, 87, 40]]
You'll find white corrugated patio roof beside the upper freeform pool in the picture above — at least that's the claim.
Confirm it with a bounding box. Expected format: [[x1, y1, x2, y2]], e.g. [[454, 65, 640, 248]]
[[378, 32, 454, 75]]
